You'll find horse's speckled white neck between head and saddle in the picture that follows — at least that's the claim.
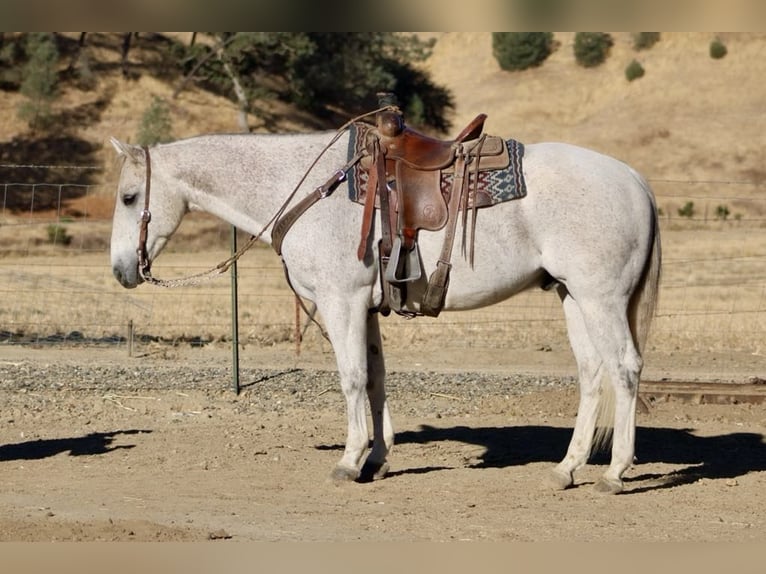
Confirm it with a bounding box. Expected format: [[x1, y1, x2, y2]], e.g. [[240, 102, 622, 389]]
[[172, 133, 345, 242]]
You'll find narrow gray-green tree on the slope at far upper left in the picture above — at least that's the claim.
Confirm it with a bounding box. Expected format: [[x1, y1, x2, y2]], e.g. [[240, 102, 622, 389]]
[[19, 33, 59, 129]]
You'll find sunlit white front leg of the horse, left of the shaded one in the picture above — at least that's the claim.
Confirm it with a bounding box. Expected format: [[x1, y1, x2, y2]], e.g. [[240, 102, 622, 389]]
[[317, 297, 376, 481]]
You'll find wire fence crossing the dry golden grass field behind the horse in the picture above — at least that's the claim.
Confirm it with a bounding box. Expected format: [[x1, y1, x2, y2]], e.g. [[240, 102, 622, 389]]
[[0, 173, 766, 375]]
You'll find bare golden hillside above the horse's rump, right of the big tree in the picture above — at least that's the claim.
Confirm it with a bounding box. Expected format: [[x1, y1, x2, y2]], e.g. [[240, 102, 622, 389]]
[[429, 33, 766, 189]]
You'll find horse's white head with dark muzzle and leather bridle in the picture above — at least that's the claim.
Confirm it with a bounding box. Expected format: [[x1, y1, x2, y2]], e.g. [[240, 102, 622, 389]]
[[111, 138, 186, 288]]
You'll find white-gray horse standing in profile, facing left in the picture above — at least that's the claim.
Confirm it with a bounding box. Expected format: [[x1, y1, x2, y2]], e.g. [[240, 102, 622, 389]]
[[111, 129, 661, 493]]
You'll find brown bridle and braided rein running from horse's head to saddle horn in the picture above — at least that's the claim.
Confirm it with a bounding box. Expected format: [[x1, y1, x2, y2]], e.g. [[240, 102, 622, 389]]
[[137, 106, 391, 290]]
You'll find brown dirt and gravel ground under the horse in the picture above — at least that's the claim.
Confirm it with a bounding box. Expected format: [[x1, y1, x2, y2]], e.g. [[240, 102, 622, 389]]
[[0, 345, 766, 542]]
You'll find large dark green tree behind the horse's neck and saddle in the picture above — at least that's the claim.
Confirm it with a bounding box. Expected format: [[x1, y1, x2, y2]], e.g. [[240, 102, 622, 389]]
[[176, 32, 454, 133]]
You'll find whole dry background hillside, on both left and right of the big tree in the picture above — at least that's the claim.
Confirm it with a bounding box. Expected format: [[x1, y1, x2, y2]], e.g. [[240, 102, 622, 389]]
[[0, 32, 766, 214]]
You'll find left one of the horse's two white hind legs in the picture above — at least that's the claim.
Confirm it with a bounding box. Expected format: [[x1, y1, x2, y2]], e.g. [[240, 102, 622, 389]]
[[546, 286, 603, 490]]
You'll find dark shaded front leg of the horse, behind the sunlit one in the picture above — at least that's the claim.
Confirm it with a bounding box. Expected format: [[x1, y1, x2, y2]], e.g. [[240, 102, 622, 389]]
[[360, 313, 394, 480]]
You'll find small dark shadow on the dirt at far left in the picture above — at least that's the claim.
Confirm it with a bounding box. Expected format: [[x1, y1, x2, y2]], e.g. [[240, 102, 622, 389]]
[[0, 429, 152, 462]]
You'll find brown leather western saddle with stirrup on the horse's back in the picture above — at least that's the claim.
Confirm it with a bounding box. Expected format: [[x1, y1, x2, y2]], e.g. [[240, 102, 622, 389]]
[[357, 101, 510, 317]]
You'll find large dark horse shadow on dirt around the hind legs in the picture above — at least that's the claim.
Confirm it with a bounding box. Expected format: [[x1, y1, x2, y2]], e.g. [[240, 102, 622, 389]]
[[318, 425, 766, 493]]
